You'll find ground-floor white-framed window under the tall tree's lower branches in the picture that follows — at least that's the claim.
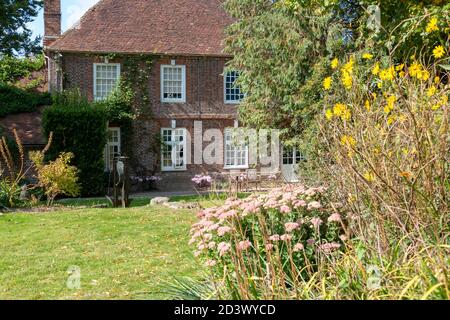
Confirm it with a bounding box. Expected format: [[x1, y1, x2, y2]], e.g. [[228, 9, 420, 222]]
[[224, 128, 248, 169]]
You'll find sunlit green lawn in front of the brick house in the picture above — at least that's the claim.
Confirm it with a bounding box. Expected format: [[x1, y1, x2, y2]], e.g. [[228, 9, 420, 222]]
[[0, 200, 201, 299]]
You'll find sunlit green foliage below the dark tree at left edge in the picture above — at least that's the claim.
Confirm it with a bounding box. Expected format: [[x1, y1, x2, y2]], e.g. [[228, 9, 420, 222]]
[[0, 54, 45, 84]]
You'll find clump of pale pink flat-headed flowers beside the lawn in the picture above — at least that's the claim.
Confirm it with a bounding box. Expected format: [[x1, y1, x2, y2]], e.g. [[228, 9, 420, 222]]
[[190, 185, 346, 297]]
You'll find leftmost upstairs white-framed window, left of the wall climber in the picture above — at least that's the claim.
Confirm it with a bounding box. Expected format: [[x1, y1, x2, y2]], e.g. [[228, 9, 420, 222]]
[[94, 63, 120, 101]]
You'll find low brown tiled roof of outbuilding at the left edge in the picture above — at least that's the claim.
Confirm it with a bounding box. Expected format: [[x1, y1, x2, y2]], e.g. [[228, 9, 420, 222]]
[[0, 109, 45, 145]]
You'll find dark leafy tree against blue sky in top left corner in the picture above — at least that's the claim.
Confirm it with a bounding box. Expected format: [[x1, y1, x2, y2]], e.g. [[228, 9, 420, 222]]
[[0, 0, 43, 56]]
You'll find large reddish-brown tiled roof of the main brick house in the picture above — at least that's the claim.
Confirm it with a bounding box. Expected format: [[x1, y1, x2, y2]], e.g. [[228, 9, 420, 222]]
[[49, 0, 233, 55]]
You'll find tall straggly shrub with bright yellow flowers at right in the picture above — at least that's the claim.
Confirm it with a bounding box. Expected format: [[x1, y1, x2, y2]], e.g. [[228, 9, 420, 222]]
[[321, 46, 450, 245]]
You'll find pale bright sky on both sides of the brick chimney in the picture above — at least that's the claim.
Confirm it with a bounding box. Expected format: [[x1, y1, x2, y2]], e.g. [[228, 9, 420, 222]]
[[29, 0, 99, 42]]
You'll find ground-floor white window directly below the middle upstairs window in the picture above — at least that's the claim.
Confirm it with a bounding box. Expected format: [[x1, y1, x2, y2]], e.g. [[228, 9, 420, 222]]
[[161, 128, 187, 171]]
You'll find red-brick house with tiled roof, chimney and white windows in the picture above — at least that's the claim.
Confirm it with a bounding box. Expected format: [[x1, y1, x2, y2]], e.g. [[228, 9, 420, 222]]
[[44, 0, 299, 188]]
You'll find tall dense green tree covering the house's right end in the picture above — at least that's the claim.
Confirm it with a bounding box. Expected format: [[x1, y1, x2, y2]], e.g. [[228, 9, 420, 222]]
[[225, 0, 345, 142]]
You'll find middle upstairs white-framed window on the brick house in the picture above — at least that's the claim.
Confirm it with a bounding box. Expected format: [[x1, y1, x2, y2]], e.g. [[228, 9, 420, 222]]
[[161, 65, 186, 103]]
